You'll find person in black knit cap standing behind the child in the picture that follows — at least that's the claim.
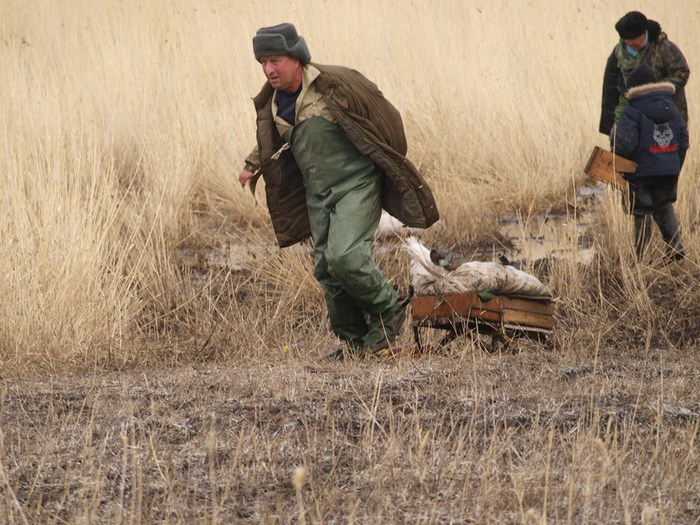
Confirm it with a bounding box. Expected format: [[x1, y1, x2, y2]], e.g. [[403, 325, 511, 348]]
[[598, 11, 690, 135]]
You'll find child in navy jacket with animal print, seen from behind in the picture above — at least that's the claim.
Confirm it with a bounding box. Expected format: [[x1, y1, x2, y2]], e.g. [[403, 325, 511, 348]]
[[613, 63, 689, 260]]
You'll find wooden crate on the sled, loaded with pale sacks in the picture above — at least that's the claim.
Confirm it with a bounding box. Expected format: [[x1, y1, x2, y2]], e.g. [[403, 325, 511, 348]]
[[411, 293, 554, 350]]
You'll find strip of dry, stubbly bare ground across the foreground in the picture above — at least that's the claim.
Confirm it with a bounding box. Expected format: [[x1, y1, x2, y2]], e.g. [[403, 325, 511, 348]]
[[0, 343, 700, 523]]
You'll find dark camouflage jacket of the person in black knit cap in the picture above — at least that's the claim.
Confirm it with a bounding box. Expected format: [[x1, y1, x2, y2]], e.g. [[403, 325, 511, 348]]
[[598, 20, 690, 135]]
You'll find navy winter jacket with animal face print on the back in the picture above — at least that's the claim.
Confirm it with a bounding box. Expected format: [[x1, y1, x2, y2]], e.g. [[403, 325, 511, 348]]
[[614, 82, 689, 183]]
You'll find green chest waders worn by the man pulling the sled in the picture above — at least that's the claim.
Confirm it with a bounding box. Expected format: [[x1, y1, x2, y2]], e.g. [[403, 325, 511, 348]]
[[290, 117, 397, 346]]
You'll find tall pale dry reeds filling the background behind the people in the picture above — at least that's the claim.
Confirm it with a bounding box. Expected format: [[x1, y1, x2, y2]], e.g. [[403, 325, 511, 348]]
[[0, 0, 700, 370]]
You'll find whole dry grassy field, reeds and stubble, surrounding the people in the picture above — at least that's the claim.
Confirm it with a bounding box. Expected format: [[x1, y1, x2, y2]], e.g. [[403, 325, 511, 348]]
[[0, 0, 700, 524]]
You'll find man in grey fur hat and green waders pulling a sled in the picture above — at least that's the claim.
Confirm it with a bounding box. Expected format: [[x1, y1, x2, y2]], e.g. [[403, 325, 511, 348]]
[[239, 23, 438, 358]]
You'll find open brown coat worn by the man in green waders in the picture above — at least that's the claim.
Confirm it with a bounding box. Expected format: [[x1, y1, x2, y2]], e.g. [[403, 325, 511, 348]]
[[251, 64, 439, 247]]
